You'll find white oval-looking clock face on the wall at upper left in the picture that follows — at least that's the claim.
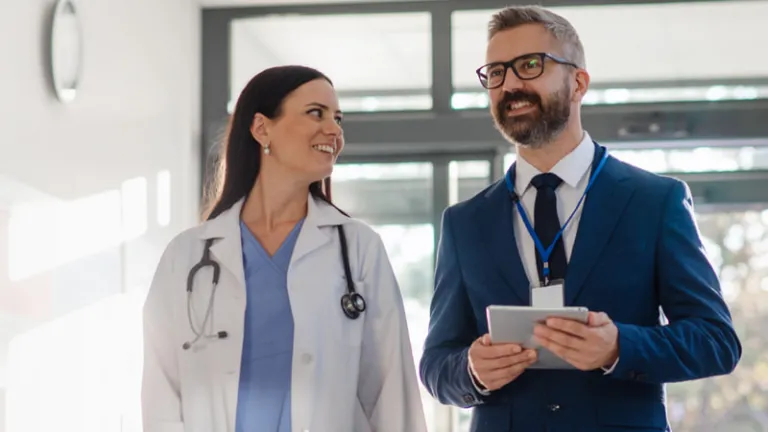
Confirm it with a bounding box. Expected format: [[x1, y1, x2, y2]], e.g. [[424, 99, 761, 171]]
[[50, 0, 82, 102]]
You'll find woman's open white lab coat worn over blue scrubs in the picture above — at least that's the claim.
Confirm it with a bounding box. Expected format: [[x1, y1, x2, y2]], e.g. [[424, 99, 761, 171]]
[[141, 196, 426, 432]]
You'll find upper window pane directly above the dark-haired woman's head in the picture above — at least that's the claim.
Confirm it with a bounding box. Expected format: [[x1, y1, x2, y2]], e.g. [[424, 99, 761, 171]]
[[230, 12, 432, 111]]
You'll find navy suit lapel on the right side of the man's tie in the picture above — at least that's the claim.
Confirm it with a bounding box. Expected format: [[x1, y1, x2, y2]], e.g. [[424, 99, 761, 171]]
[[565, 152, 634, 305]]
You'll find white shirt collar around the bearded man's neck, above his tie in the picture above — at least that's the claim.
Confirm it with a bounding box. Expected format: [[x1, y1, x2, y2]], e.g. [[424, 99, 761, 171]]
[[515, 131, 595, 193]]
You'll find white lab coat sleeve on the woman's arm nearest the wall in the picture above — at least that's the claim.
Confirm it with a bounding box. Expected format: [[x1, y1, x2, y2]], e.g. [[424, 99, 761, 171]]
[[141, 246, 184, 432]]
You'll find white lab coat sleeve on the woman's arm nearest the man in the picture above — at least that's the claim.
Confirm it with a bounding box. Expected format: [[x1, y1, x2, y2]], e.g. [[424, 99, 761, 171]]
[[358, 231, 427, 432]]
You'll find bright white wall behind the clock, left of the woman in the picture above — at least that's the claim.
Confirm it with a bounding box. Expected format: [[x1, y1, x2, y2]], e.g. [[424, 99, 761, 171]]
[[0, 0, 200, 432]]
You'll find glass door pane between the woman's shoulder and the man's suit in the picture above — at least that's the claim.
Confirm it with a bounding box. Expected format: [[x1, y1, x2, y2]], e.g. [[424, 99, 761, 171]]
[[333, 162, 439, 431]]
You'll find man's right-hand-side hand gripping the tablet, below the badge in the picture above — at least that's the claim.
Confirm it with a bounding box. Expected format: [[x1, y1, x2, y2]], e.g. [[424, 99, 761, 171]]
[[533, 312, 619, 371]]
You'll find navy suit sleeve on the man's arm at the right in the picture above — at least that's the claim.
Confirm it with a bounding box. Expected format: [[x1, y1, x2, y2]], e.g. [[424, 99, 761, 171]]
[[611, 181, 742, 383]]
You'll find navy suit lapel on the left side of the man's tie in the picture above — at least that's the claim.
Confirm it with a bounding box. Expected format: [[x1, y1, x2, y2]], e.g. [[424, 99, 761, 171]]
[[476, 178, 530, 305]]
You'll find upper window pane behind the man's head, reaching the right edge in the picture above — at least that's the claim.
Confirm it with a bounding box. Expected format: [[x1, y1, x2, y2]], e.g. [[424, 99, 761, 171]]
[[452, 1, 768, 104]]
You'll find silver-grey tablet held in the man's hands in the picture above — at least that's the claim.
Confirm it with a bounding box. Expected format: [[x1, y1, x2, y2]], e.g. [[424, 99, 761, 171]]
[[486, 305, 589, 369]]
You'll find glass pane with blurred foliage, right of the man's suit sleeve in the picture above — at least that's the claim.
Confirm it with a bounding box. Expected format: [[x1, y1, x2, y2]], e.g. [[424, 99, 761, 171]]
[[667, 211, 768, 432]]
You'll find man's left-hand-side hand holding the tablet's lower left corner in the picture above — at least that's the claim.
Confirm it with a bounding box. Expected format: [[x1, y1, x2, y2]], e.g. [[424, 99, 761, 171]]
[[469, 334, 537, 390]]
